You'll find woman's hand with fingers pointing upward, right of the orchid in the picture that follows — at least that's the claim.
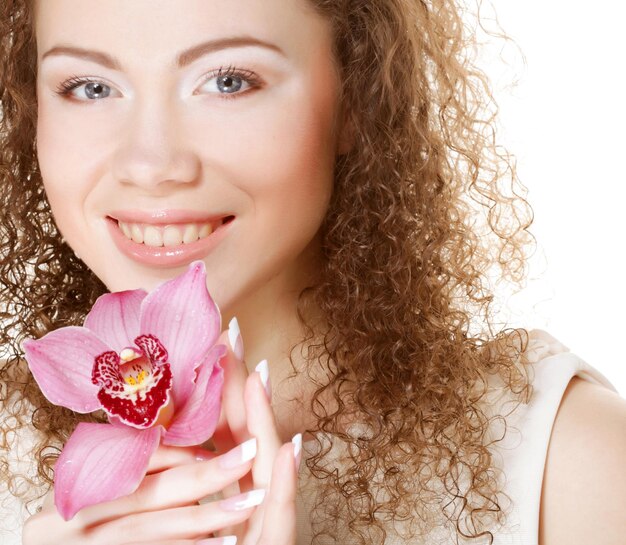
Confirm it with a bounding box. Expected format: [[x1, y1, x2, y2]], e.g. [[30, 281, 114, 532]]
[[213, 320, 302, 545]]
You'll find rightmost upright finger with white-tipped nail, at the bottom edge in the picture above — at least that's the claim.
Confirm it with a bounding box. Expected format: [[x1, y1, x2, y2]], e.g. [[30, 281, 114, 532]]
[[257, 436, 302, 545]]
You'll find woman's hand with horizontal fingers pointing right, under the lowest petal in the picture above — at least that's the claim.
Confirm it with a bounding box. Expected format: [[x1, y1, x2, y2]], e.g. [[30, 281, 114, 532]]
[[22, 440, 263, 545]]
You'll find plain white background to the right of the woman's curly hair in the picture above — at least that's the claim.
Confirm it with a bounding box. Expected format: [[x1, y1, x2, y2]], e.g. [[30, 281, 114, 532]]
[[480, 0, 626, 397]]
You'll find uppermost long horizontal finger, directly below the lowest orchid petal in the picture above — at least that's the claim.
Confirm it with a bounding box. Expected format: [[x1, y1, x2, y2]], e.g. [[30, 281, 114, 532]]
[[76, 439, 257, 526]]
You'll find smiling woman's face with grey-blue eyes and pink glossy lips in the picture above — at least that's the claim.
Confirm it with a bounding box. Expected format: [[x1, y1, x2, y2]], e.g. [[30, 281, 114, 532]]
[[36, 0, 342, 310]]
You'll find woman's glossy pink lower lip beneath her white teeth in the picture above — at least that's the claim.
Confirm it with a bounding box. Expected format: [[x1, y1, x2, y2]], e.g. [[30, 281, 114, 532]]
[[106, 214, 234, 268]]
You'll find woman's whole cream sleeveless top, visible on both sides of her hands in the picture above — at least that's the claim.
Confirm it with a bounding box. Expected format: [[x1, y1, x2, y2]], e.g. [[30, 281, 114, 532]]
[[0, 329, 617, 545]]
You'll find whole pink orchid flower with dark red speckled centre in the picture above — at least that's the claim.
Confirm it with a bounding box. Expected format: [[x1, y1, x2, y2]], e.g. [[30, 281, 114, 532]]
[[23, 261, 226, 520]]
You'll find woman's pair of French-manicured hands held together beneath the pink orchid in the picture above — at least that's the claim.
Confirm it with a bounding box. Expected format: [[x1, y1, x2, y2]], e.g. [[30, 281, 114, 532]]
[[22, 318, 301, 545]]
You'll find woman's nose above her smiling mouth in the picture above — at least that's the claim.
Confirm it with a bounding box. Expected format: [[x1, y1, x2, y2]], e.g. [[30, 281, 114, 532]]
[[113, 101, 201, 195]]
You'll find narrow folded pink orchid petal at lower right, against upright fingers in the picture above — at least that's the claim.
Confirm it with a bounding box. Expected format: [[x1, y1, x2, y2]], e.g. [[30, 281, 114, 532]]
[[163, 344, 226, 447]]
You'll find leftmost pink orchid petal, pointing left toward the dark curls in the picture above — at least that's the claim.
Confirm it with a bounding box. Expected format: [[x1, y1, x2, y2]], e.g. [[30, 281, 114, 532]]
[[22, 326, 109, 413]]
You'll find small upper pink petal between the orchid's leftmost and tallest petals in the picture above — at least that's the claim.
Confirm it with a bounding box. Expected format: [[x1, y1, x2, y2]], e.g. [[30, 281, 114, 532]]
[[84, 290, 148, 353]]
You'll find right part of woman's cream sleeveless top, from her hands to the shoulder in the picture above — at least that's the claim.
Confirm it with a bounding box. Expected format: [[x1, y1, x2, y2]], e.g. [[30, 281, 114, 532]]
[[297, 329, 617, 545]]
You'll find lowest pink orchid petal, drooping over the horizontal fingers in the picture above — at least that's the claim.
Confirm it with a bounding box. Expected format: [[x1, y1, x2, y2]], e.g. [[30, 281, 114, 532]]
[[54, 422, 162, 520]]
